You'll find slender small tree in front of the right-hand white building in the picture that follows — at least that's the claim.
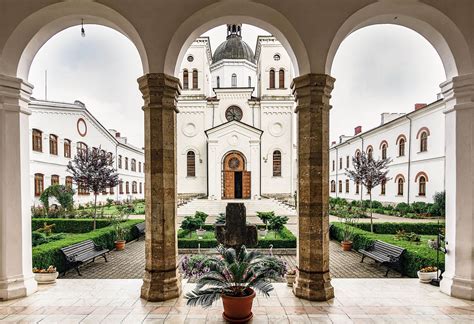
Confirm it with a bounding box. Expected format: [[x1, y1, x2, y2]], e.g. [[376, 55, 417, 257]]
[[346, 152, 392, 232]]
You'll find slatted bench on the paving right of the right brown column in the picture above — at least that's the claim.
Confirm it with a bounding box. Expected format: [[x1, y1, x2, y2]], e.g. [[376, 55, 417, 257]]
[[359, 240, 405, 277]]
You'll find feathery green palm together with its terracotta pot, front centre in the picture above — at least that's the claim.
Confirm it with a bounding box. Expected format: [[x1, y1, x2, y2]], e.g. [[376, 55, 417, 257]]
[[185, 245, 286, 322]]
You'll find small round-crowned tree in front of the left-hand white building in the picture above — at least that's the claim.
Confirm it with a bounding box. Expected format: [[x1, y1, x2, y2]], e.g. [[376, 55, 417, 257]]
[[67, 147, 120, 230]]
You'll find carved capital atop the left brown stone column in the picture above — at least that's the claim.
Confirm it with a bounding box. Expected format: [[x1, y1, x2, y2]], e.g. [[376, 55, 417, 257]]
[[137, 73, 181, 112]]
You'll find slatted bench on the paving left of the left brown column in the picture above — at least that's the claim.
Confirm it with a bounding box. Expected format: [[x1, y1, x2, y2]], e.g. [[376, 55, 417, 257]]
[[61, 240, 109, 276]]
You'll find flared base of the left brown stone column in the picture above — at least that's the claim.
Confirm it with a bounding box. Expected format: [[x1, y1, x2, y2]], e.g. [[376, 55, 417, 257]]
[[141, 269, 182, 301]]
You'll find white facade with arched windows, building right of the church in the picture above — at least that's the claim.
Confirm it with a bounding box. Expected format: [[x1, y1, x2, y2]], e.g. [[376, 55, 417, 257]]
[[329, 100, 445, 204]]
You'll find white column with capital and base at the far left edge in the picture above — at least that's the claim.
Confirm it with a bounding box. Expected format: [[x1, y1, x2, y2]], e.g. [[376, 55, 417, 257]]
[[0, 75, 37, 300]]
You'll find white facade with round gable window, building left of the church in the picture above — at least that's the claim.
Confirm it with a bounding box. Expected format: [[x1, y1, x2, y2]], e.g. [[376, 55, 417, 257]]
[[29, 100, 145, 205]]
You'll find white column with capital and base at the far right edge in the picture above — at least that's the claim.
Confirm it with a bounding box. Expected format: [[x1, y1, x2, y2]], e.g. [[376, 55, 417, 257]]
[[439, 74, 474, 300]]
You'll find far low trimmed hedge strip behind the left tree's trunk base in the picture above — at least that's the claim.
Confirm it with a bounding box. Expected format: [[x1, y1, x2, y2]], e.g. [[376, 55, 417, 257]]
[[31, 218, 111, 233]]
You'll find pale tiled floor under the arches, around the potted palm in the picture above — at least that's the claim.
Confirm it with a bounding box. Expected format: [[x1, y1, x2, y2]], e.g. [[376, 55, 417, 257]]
[[0, 278, 474, 324]]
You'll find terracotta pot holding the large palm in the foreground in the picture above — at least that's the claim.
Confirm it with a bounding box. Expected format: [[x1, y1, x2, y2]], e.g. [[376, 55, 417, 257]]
[[221, 288, 255, 323]]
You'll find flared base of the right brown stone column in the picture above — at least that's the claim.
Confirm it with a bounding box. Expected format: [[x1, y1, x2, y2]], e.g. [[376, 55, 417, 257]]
[[293, 270, 334, 301]]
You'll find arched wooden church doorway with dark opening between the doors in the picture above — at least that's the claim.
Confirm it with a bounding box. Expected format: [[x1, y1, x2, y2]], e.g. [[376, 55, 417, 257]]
[[222, 151, 251, 199]]
